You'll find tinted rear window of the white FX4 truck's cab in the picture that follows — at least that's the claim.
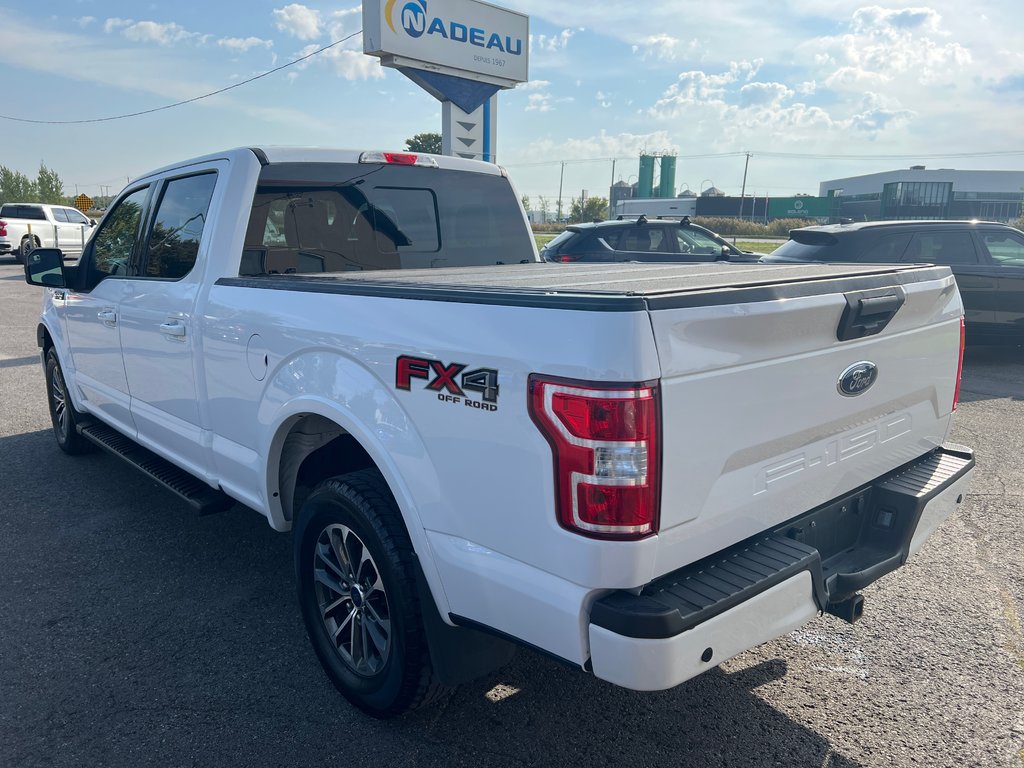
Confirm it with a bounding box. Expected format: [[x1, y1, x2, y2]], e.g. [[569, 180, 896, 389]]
[[240, 163, 535, 275]]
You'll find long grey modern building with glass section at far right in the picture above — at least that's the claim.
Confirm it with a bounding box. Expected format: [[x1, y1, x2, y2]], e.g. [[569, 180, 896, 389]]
[[818, 165, 1024, 221]]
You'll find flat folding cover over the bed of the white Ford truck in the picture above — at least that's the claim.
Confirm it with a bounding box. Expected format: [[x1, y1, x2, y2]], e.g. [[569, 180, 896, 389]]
[[217, 262, 948, 311]]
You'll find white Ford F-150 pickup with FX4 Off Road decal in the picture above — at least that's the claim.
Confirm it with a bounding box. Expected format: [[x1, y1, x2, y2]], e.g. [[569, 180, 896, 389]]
[[26, 147, 974, 717]]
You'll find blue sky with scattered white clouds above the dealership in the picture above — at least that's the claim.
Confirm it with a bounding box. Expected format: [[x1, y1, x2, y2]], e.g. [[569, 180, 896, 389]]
[[0, 0, 1024, 207]]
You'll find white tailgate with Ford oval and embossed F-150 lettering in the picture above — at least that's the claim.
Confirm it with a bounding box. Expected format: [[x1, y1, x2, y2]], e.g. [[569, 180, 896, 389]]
[[650, 266, 962, 574]]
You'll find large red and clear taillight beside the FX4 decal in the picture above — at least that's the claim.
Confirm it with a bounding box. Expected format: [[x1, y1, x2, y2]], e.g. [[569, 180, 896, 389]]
[[529, 375, 662, 540]]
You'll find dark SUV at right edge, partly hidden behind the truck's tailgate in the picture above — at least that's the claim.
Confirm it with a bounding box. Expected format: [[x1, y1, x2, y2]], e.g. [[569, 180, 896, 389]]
[[761, 221, 1024, 344]]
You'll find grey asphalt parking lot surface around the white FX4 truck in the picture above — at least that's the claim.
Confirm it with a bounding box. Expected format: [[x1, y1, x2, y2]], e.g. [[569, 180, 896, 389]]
[[0, 259, 1024, 768]]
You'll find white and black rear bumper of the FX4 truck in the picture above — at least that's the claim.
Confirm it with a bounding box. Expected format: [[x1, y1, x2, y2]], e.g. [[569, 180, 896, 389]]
[[589, 445, 974, 690]]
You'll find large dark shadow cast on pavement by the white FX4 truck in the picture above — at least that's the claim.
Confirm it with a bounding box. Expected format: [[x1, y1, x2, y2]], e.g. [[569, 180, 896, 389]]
[[0, 430, 858, 768]]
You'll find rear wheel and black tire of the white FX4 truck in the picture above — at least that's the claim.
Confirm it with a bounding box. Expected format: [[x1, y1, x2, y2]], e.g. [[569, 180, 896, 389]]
[[294, 469, 446, 718]]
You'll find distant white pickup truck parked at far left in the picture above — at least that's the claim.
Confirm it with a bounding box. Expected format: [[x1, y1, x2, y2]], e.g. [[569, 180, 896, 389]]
[[0, 203, 96, 263]]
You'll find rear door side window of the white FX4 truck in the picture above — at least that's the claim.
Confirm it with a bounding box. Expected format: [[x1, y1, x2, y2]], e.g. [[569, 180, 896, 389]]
[[145, 173, 217, 280]]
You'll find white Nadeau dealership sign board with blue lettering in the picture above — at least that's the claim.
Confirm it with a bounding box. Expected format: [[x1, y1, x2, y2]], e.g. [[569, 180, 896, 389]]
[[362, 0, 529, 88]]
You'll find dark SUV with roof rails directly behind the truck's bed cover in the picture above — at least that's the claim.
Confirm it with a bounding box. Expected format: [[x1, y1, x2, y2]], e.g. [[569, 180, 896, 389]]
[[541, 216, 756, 263]]
